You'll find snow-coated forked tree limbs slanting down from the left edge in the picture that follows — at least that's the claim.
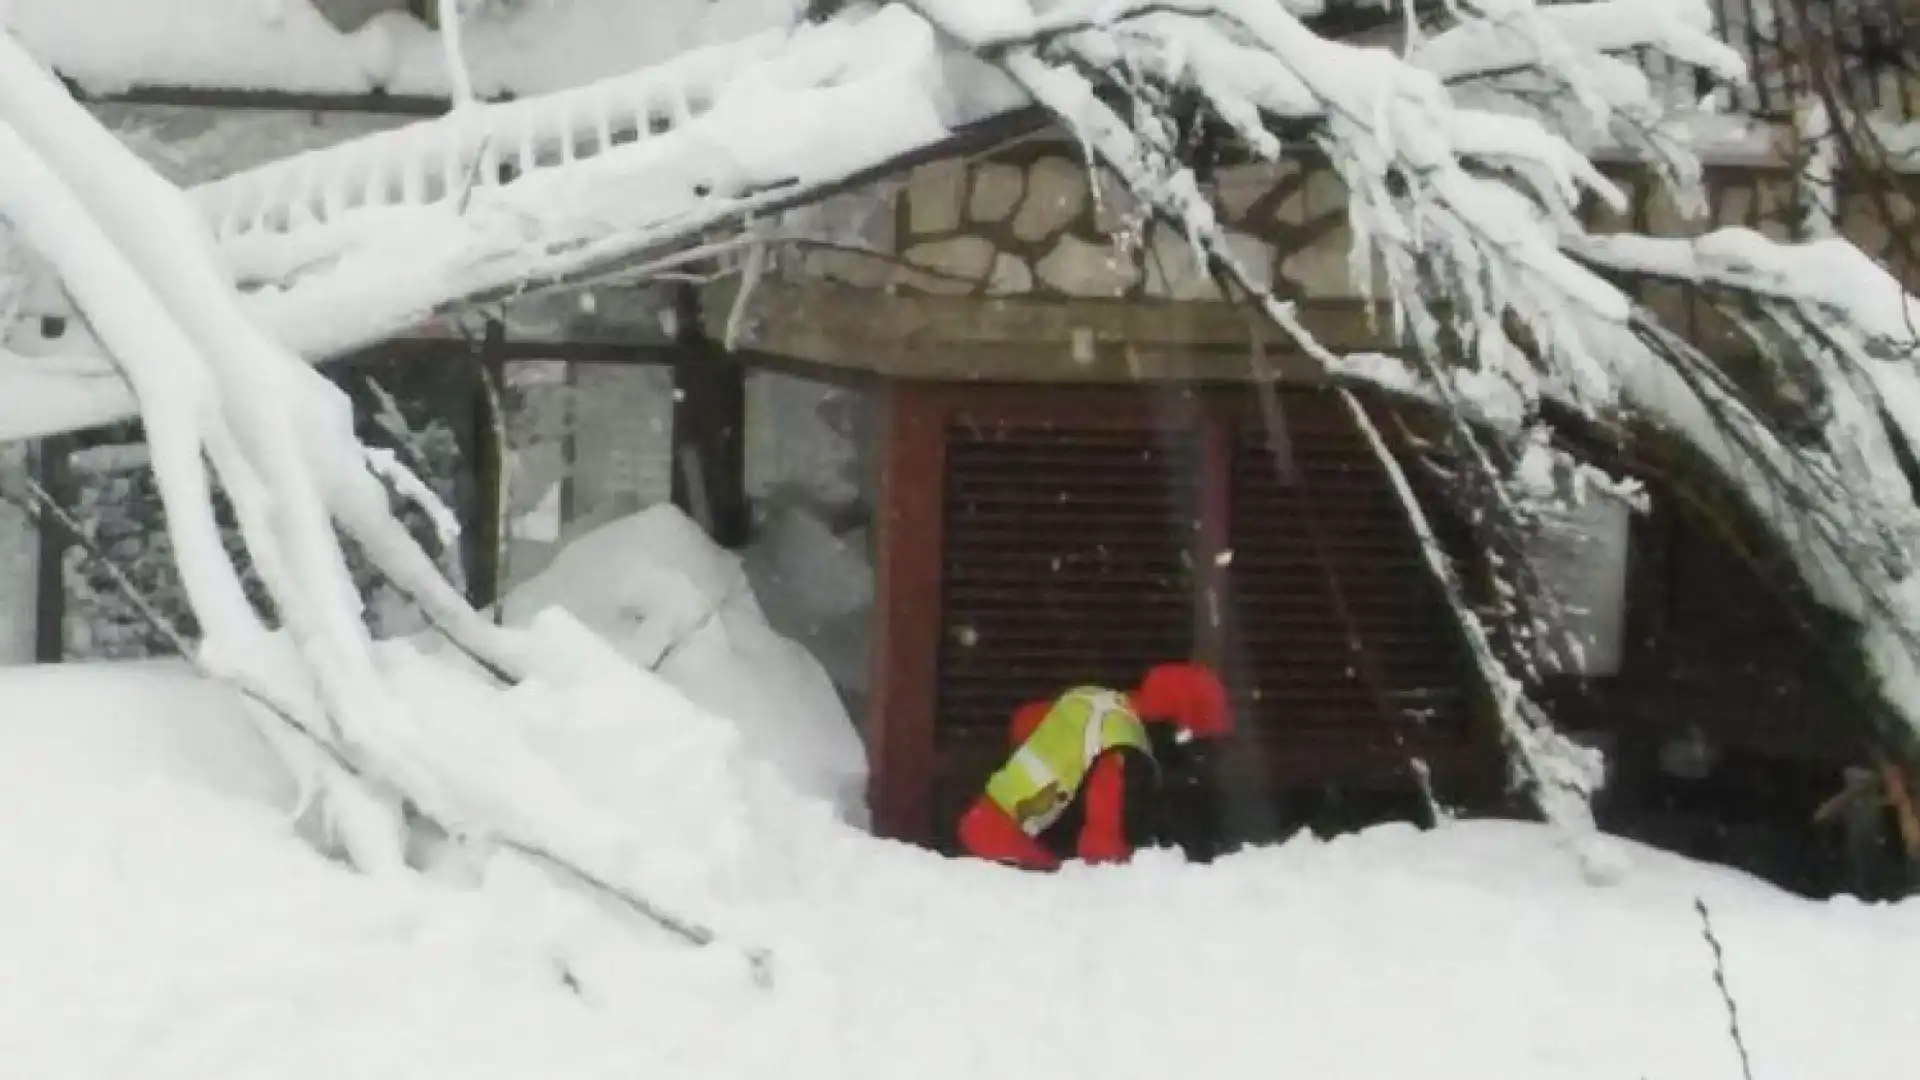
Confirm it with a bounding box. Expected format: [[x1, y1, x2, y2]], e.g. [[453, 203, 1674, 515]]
[[0, 27, 779, 957]]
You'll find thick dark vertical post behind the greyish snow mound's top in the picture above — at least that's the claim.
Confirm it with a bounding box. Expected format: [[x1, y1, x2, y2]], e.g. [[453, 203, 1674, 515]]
[[672, 286, 751, 548]]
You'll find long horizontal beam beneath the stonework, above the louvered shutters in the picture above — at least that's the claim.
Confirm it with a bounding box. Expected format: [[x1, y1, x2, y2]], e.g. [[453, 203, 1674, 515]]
[[708, 281, 1390, 384]]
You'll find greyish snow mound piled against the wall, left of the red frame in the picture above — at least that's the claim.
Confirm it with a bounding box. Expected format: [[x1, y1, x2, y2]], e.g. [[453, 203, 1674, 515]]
[[505, 503, 866, 821]]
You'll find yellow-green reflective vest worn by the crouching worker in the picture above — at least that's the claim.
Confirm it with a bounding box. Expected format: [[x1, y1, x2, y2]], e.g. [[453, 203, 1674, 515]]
[[987, 686, 1152, 836]]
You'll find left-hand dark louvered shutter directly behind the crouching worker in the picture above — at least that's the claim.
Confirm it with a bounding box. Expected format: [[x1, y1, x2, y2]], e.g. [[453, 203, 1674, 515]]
[[935, 421, 1198, 834]]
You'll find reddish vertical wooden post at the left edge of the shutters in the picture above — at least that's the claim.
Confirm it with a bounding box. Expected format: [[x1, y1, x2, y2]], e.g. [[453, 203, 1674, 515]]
[[866, 384, 947, 844]]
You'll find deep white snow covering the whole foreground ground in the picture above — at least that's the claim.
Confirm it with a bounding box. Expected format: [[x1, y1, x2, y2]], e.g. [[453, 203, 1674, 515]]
[[0, 638, 1920, 1080]]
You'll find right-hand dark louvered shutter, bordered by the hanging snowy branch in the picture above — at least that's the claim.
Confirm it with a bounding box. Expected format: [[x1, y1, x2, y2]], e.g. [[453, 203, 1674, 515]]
[[1225, 392, 1494, 788]]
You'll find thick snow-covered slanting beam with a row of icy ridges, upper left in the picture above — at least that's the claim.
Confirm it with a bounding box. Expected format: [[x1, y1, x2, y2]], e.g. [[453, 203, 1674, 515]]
[[0, 6, 975, 438]]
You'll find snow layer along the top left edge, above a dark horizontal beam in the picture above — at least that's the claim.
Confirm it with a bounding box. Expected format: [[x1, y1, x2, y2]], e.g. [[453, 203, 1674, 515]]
[[0, 0, 801, 98]]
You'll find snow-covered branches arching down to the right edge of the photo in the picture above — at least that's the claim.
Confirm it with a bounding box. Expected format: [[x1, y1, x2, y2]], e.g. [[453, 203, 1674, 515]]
[[1572, 229, 1920, 744]]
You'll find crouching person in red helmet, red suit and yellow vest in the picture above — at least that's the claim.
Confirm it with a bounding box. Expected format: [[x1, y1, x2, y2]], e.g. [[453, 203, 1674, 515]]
[[958, 663, 1231, 871]]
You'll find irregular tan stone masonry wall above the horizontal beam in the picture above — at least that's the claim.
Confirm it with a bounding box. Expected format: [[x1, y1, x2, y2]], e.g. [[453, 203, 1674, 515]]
[[803, 142, 1912, 302]]
